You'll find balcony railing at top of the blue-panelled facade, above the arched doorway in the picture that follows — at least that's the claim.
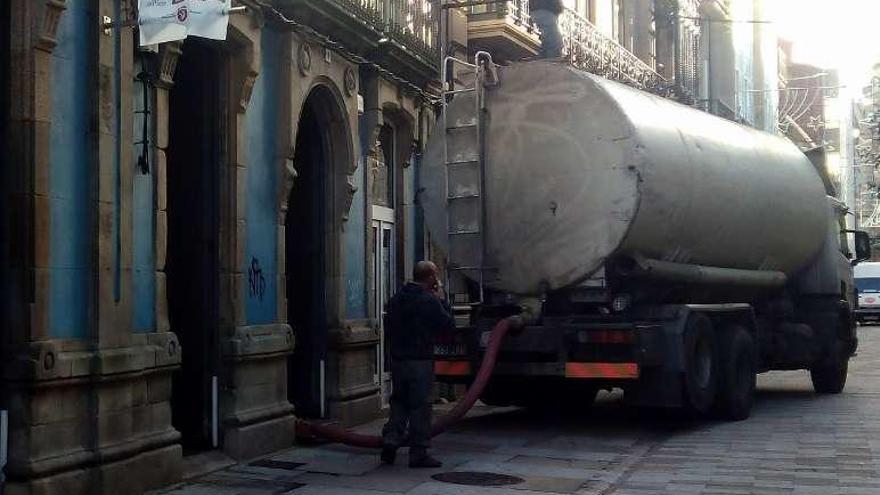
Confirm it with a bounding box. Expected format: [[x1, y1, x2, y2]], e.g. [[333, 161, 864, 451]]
[[331, 0, 440, 65]]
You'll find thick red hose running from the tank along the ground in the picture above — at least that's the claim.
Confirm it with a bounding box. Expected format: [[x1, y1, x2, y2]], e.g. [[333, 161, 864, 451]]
[[296, 318, 515, 448]]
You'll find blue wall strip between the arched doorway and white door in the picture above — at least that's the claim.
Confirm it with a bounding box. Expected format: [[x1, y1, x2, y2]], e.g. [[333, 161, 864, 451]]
[[343, 110, 367, 320]]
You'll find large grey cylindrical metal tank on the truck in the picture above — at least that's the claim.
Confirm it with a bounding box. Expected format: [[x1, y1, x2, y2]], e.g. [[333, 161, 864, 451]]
[[419, 61, 829, 295]]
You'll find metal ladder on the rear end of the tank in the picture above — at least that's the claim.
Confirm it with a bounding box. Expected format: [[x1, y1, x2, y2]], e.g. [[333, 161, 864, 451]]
[[441, 51, 498, 305]]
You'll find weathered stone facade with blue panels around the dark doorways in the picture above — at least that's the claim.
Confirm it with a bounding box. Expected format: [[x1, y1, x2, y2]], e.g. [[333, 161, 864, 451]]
[[0, 0, 440, 494]]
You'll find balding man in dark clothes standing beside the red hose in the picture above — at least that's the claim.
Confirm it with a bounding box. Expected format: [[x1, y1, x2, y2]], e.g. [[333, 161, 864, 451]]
[[382, 261, 455, 468]]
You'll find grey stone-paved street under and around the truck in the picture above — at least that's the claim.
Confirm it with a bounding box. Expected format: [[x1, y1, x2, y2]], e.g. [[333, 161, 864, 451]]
[[156, 327, 880, 495]]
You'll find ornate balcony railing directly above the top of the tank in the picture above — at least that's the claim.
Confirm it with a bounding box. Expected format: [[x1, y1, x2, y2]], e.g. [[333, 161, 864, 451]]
[[560, 9, 671, 96]]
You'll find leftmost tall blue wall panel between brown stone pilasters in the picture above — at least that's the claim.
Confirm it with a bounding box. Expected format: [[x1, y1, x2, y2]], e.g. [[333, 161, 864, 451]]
[[49, 0, 94, 338]]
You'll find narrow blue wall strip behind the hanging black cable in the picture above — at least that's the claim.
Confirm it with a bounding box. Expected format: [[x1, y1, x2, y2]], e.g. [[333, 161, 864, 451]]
[[128, 59, 156, 332]]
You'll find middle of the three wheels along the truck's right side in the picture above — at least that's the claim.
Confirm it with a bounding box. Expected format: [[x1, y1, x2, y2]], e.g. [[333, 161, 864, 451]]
[[715, 325, 757, 421]]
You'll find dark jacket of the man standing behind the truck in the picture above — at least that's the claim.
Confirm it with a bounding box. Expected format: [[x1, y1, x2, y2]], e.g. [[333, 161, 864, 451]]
[[388, 283, 455, 361]]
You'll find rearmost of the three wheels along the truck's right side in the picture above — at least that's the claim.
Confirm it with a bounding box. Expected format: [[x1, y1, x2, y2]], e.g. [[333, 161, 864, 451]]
[[683, 313, 718, 415]]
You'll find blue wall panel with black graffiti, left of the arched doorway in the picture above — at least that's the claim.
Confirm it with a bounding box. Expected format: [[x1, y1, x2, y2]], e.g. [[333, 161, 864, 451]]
[[244, 29, 282, 325]]
